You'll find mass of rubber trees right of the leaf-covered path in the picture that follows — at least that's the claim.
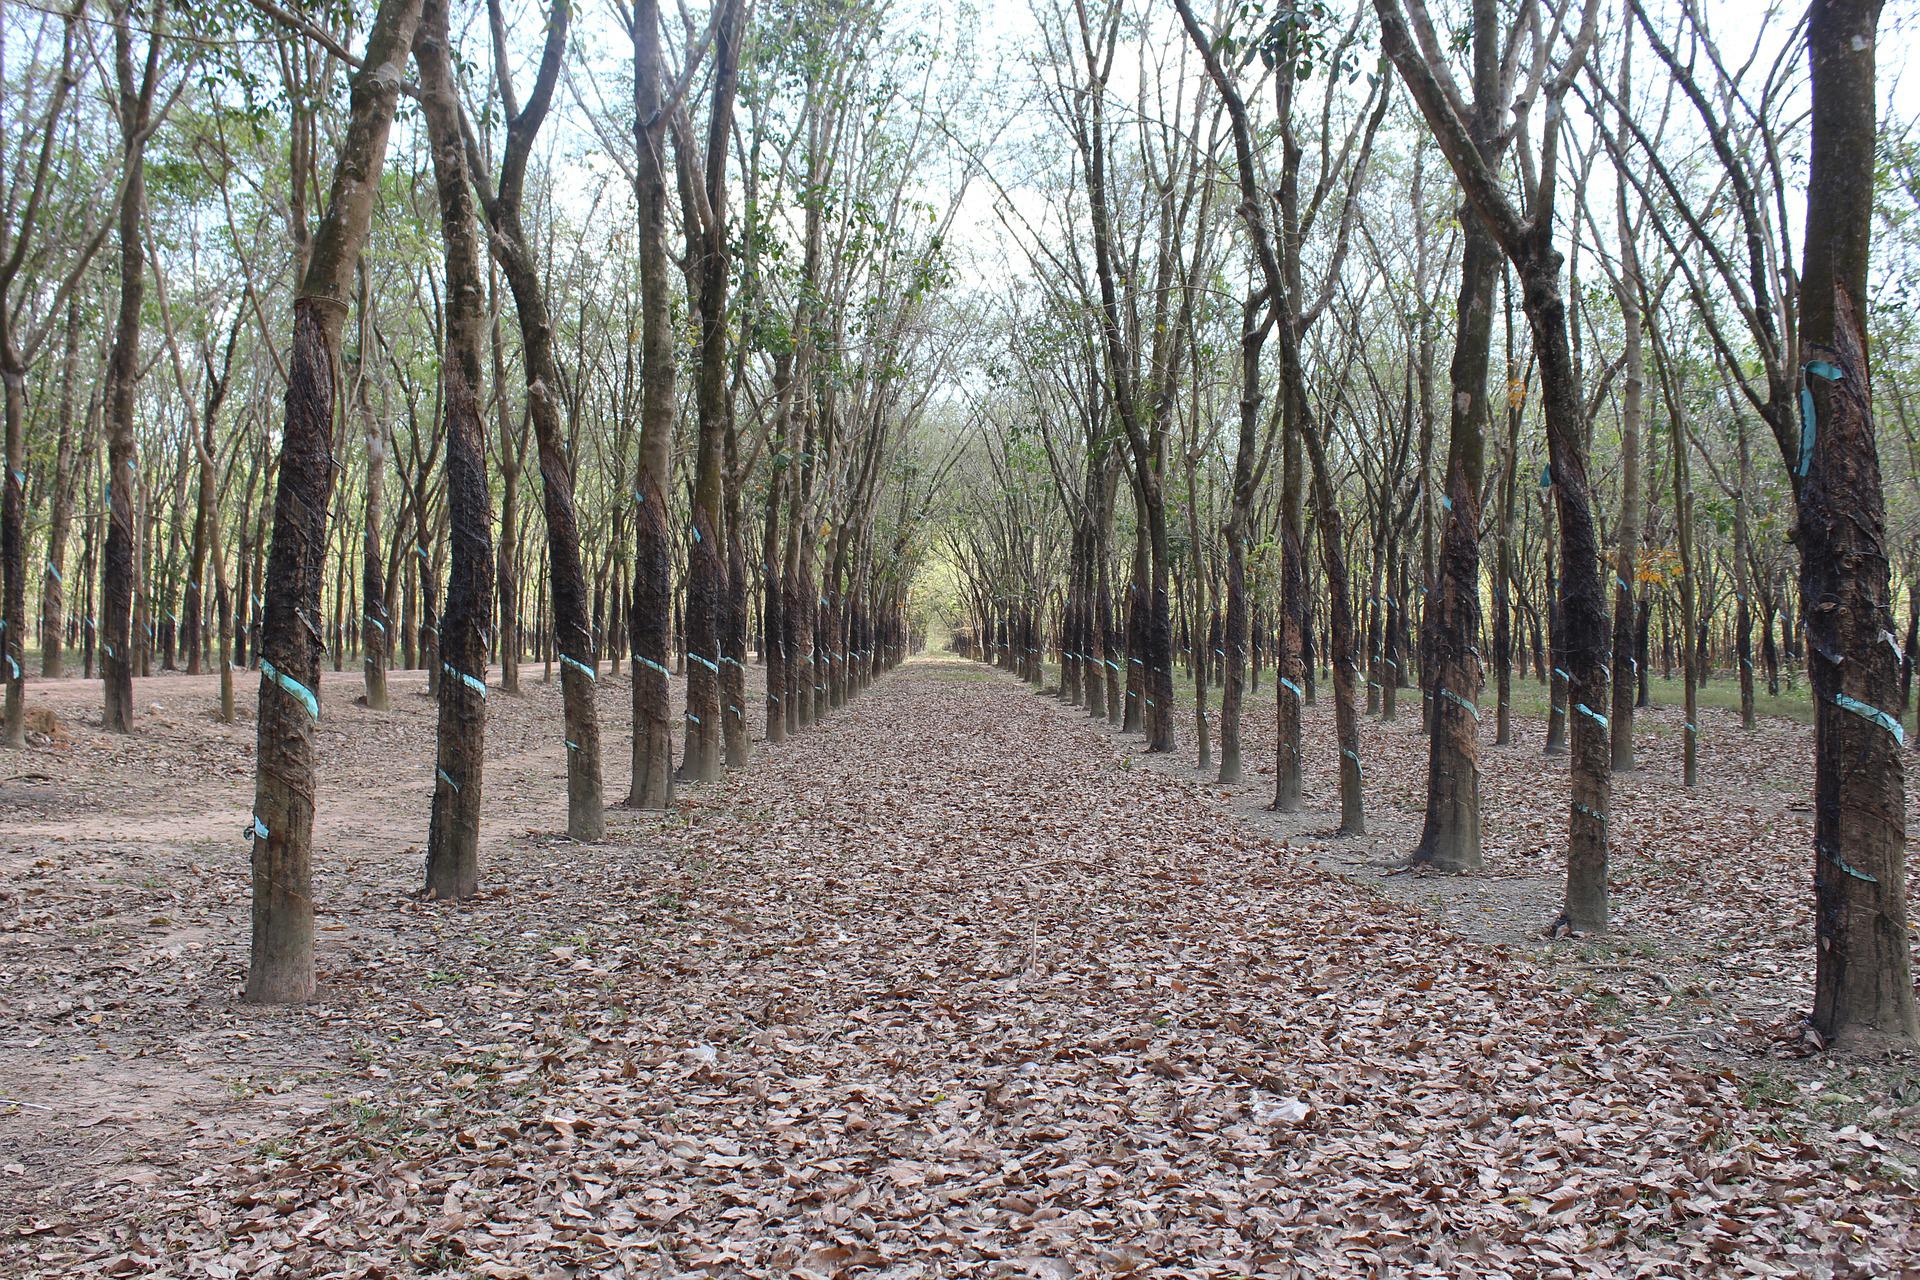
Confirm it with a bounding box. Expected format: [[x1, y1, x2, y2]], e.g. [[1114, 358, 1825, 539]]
[[943, 0, 1920, 1040]]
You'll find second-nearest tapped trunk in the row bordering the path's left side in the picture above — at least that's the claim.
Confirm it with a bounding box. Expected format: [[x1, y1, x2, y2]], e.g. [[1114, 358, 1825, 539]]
[[413, 0, 493, 898]]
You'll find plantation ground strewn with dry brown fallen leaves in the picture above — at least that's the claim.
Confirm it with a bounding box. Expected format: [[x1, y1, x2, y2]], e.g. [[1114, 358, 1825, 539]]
[[0, 658, 1920, 1280]]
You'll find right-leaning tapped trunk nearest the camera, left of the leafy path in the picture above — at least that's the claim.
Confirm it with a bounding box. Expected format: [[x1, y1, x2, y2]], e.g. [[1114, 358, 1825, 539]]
[[247, 0, 420, 1004]]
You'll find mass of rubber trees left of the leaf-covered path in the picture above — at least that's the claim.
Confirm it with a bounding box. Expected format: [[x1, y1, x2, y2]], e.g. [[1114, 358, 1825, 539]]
[[0, 0, 968, 1002]]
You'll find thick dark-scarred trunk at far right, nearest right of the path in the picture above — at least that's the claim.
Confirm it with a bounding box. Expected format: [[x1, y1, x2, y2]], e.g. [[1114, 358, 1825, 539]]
[[1793, 0, 1920, 1048]]
